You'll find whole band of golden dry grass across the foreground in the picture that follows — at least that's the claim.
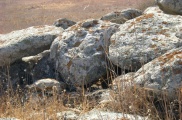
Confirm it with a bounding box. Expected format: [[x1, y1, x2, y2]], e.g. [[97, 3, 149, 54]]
[[0, 71, 182, 120]]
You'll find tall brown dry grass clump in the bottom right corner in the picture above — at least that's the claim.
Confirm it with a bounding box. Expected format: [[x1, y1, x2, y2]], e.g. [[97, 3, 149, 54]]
[[104, 80, 182, 120]]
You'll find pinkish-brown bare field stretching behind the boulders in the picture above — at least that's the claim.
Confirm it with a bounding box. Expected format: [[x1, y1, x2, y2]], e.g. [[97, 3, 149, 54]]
[[0, 0, 154, 34]]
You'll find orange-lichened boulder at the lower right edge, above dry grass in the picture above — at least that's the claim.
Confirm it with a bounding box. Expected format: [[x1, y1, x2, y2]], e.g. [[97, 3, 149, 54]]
[[134, 47, 182, 99]]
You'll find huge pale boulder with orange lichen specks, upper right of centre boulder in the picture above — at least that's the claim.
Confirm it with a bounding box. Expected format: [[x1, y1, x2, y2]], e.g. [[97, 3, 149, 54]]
[[109, 7, 182, 71]]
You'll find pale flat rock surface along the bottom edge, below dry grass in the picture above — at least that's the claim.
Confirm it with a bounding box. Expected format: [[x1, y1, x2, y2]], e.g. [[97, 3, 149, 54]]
[[57, 109, 149, 120]]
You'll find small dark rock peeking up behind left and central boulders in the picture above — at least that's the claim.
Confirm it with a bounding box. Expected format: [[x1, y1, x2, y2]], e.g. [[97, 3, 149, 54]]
[[54, 18, 76, 29]]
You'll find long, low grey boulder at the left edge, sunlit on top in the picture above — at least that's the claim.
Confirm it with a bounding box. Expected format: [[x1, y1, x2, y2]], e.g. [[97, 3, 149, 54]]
[[0, 25, 63, 66]]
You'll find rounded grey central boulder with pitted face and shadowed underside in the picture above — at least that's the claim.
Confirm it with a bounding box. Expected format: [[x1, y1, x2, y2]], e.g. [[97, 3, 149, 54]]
[[50, 19, 118, 86]]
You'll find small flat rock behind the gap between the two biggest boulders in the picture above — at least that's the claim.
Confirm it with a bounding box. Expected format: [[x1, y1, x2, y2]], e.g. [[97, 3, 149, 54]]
[[101, 8, 142, 24]]
